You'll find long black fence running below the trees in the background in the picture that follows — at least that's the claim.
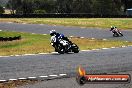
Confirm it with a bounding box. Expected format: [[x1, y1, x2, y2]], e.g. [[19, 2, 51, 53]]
[[0, 13, 132, 18]]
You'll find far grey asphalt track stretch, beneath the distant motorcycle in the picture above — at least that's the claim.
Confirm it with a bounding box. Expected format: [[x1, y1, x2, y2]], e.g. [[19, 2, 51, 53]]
[[0, 22, 132, 41]]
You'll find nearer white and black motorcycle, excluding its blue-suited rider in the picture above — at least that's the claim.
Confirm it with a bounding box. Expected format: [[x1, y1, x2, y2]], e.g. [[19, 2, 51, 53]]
[[51, 37, 79, 54]]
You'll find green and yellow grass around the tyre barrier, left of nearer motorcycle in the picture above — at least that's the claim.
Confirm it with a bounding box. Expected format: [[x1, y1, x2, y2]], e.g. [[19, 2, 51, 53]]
[[0, 31, 53, 55]]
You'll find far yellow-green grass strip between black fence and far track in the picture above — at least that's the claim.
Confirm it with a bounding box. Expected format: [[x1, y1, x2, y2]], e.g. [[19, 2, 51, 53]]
[[0, 18, 132, 29]]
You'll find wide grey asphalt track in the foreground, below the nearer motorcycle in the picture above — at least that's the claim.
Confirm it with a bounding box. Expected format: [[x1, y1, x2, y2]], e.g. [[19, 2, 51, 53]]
[[0, 47, 132, 79]]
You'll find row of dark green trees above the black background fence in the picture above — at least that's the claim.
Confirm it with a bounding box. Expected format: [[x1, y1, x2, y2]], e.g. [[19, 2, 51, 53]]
[[0, 0, 132, 15]]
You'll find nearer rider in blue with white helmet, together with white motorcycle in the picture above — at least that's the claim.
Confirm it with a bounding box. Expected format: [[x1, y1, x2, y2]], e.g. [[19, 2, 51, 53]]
[[50, 30, 79, 54]]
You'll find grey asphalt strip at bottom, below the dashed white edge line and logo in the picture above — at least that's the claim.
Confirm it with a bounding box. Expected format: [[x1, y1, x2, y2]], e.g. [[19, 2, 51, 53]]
[[19, 72, 132, 88]]
